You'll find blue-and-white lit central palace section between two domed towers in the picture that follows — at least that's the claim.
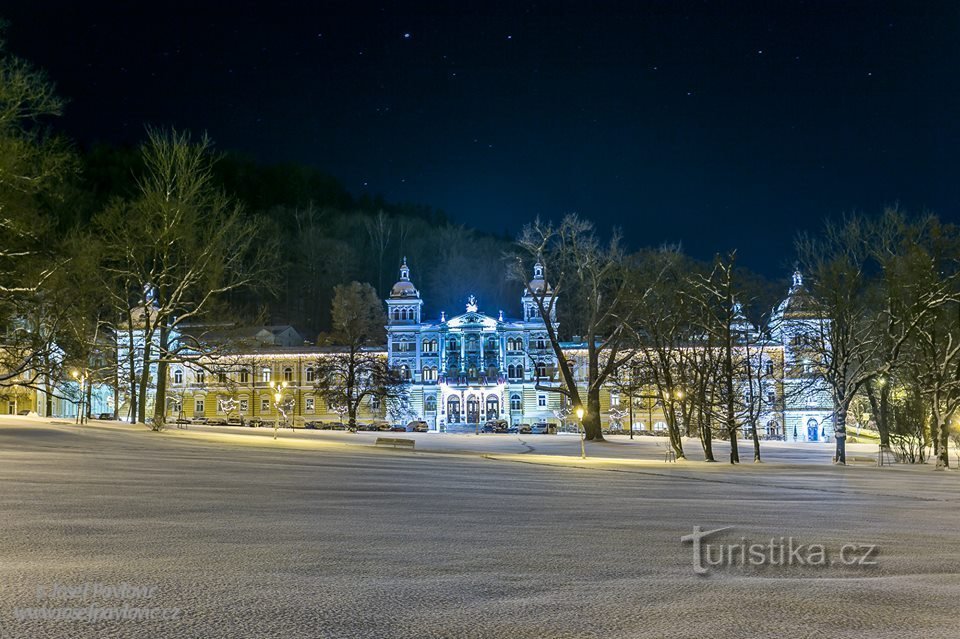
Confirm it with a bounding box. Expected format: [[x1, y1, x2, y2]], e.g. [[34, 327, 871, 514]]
[[386, 260, 562, 431]]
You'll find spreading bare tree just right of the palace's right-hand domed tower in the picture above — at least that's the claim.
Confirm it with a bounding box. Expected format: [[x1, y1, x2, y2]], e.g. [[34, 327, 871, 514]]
[[796, 209, 948, 464]]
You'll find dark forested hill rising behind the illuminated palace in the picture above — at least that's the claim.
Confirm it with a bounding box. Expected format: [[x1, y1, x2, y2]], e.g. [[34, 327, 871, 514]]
[[77, 145, 520, 338]]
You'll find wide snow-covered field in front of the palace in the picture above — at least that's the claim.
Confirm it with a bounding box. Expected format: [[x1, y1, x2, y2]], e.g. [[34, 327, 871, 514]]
[[0, 418, 960, 639]]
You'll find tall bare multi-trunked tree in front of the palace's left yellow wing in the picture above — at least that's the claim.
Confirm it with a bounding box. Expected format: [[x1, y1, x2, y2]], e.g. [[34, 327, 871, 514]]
[[94, 130, 275, 428]]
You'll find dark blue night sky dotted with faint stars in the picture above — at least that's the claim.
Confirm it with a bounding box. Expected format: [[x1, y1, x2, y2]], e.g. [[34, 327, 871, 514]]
[[7, 1, 960, 274]]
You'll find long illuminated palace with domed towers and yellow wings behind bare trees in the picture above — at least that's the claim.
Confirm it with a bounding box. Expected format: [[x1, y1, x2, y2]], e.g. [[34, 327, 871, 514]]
[[103, 260, 833, 441]]
